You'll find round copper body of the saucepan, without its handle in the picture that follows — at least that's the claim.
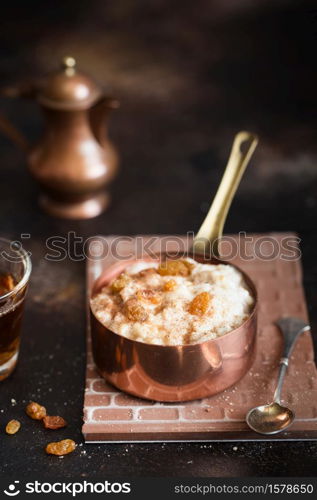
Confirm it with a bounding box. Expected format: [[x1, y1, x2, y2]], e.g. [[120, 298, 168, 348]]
[[90, 254, 257, 402]]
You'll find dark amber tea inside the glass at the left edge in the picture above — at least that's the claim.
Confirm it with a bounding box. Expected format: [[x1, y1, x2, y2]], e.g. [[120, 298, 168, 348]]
[[0, 274, 24, 380]]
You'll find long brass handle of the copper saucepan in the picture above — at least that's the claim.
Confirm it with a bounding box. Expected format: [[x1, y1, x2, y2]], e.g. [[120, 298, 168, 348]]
[[193, 132, 258, 257]]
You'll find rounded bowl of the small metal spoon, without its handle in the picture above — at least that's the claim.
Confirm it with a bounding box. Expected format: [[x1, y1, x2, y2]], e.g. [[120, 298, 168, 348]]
[[246, 402, 295, 434]]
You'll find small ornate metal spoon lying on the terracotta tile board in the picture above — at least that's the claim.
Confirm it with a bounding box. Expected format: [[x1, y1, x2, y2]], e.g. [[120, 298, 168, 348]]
[[246, 318, 310, 434]]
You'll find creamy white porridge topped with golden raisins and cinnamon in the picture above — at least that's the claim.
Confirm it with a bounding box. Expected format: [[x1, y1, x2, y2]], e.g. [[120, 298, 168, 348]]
[[91, 258, 254, 345]]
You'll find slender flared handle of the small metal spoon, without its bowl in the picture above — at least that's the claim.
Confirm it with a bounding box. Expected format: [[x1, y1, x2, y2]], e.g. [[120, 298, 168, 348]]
[[274, 318, 310, 404]]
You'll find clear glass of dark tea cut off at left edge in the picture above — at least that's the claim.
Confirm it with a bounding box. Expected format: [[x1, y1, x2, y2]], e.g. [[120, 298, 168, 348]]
[[0, 238, 32, 381]]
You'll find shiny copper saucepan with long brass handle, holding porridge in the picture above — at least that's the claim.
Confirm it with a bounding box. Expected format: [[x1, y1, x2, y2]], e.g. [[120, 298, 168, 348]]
[[90, 132, 257, 402]]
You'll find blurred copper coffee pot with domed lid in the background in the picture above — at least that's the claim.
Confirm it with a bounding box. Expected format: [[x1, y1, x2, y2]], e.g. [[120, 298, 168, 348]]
[[0, 57, 119, 219]]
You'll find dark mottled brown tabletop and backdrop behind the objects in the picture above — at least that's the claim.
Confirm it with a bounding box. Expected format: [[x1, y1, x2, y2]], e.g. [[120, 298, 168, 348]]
[[0, 0, 317, 478]]
